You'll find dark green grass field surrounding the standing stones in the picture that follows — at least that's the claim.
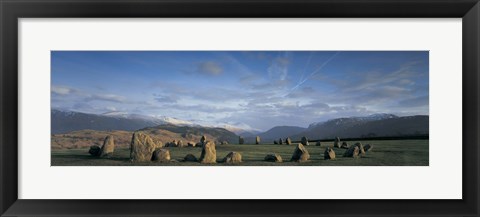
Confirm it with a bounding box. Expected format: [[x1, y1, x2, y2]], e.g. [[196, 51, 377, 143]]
[[51, 140, 428, 166]]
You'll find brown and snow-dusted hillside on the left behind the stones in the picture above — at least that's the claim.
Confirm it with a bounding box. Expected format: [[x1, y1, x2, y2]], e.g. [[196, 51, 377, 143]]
[[51, 110, 238, 148]]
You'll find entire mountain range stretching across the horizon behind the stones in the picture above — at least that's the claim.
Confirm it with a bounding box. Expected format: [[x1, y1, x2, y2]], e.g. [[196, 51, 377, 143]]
[[51, 109, 429, 142]]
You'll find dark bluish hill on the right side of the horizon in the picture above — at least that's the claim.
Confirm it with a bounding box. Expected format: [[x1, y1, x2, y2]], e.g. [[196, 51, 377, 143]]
[[292, 115, 429, 140]]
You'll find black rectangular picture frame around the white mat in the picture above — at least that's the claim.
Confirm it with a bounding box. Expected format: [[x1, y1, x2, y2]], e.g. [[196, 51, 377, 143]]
[[0, 0, 480, 216]]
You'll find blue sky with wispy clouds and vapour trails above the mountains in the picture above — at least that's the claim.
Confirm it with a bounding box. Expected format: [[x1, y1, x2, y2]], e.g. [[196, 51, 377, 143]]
[[51, 51, 429, 131]]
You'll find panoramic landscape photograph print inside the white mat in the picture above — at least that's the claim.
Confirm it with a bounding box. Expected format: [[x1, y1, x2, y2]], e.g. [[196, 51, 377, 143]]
[[51, 50, 429, 166]]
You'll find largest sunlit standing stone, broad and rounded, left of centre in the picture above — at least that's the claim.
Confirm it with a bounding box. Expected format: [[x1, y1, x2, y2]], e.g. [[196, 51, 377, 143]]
[[130, 132, 156, 161]]
